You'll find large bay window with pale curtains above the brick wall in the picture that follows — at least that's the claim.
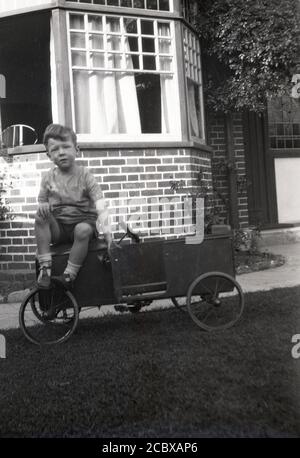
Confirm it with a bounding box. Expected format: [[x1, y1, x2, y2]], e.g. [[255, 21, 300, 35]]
[[0, 0, 204, 145]]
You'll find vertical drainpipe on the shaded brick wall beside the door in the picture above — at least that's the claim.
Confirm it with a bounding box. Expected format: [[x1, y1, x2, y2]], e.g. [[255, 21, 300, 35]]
[[224, 113, 239, 229]]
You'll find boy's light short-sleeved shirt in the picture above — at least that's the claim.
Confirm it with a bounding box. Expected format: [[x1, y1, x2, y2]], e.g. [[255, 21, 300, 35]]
[[38, 165, 103, 224]]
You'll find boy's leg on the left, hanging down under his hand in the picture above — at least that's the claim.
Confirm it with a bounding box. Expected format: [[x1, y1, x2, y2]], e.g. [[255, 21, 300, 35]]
[[35, 214, 60, 287]]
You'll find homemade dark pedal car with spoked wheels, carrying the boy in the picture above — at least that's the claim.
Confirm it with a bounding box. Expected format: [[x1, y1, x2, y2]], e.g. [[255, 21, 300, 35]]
[[19, 229, 244, 345]]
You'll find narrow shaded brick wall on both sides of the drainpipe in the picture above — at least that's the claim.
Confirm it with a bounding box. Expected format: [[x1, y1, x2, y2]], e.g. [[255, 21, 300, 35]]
[[208, 113, 249, 227]]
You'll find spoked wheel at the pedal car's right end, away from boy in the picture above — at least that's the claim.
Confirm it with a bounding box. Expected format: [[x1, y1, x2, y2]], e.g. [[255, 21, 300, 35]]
[[187, 272, 244, 331]]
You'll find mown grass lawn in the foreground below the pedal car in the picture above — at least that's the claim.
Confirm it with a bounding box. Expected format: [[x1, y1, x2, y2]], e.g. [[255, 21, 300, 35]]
[[0, 288, 300, 438]]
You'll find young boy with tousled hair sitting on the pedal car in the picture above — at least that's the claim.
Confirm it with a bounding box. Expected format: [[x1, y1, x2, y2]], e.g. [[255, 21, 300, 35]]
[[35, 124, 113, 288]]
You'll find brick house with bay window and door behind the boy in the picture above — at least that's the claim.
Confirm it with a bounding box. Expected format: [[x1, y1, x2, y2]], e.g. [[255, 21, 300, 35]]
[[0, 0, 300, 270]]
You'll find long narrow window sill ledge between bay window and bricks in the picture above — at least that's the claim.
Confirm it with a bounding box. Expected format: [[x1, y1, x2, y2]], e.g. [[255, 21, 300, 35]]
[[0, 141, 212, 158]]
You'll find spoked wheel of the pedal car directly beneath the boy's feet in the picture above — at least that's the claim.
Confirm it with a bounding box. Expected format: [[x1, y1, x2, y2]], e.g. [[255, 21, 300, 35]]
[[19, 283, 79, 345]]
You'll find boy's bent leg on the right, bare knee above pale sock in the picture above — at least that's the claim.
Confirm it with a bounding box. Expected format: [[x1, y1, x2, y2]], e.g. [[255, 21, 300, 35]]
[[64, 222, 94, 280]]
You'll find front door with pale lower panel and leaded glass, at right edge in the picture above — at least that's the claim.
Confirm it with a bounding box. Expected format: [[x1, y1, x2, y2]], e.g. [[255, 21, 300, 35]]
[[244, 97, 300, 228]]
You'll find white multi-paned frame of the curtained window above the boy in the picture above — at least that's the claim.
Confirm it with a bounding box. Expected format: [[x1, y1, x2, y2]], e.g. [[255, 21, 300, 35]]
[[66, 10, 183, 143]]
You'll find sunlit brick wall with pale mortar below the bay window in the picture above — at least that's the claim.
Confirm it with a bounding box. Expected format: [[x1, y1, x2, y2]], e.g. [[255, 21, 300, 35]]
[[0, 148, 211, 270]]
